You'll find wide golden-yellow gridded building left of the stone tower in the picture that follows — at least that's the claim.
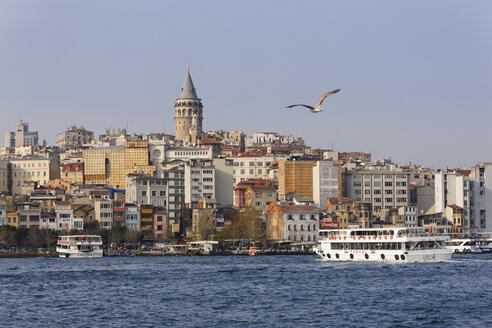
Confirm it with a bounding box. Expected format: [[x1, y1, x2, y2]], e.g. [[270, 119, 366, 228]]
[[83, 140, 155, 189]]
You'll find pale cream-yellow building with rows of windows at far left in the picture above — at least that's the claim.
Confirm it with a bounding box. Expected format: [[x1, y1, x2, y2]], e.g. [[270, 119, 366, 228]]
[[9, 157, 60, 195]]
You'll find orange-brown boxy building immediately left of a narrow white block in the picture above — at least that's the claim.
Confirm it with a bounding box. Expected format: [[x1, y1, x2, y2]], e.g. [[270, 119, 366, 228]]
[[278, 161, 316, 199]]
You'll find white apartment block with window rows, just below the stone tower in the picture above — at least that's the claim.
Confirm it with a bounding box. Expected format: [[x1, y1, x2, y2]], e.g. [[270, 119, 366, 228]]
[[184, 161, 215, 208]]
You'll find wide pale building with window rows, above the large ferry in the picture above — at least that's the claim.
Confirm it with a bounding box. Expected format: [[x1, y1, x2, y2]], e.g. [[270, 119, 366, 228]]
[[343, 170, 410, 210]]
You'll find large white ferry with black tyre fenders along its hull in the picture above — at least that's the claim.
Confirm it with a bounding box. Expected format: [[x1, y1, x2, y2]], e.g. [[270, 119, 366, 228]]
[[314, 226, 453, 263]]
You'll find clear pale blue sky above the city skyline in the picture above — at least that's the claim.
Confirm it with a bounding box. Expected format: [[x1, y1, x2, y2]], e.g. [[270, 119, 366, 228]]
[[0, 0, 492, 168]]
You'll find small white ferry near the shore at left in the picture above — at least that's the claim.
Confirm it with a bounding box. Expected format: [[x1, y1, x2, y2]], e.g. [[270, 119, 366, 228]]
[[56, 235, 103, 258]]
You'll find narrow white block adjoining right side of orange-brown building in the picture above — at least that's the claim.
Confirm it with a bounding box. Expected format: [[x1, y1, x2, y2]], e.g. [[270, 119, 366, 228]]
[[313, 161, 338, 210]]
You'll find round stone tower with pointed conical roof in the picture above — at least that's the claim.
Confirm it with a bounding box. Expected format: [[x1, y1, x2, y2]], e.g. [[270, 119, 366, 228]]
[[174, 65, 203, 144]]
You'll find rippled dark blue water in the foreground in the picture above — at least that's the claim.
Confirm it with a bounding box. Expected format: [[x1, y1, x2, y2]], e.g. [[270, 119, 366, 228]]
[[0, 254, 492, 327]]
